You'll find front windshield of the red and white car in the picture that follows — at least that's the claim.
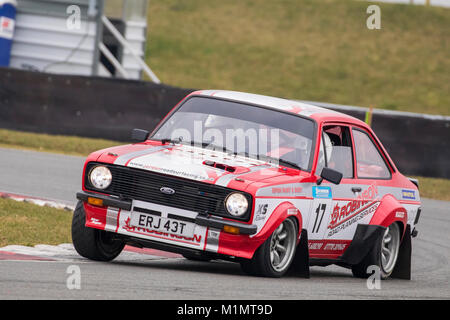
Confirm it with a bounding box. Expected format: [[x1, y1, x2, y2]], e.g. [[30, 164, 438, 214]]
[[151, 97, 314, 171]]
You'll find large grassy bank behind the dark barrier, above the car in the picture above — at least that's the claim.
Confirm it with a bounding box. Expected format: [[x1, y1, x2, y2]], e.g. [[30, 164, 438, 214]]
[[146, 0, 450, 115]]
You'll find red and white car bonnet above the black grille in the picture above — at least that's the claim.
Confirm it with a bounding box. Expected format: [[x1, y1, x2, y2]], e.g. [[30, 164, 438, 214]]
[[97, 144, 282, 190]]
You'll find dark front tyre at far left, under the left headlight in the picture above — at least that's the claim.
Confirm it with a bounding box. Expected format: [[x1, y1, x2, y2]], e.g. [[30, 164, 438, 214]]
[[72, 201, 125, 261]]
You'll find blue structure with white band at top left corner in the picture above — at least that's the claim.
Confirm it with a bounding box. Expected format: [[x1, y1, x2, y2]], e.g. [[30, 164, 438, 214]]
[[0, 0, 17, 67]]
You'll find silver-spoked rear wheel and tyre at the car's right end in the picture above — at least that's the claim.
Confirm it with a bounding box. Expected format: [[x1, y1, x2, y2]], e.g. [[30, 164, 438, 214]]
[[352, 223, 401, 280]]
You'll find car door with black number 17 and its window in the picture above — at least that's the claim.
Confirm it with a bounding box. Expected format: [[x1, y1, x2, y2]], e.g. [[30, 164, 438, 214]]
[[307, 123, 365, 258]]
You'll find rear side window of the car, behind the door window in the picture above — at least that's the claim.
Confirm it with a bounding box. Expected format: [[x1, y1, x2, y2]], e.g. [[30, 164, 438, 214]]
[[353, 129, 391, 179]]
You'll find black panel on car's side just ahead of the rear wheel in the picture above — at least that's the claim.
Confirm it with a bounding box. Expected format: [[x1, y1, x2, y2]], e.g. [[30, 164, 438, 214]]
[[340, 224, 386, 266]]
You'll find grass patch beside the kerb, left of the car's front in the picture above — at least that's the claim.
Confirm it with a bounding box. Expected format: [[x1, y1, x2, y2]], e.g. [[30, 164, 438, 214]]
[[0, 198, 72, 247]]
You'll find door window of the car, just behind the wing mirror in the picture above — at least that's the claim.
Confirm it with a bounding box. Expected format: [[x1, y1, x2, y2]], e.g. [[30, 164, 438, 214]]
[[316, 126, 353, 178]]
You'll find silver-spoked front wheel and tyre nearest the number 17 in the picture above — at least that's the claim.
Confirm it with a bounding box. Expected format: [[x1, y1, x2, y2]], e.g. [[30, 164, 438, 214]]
[[241, 218, 298, 278]]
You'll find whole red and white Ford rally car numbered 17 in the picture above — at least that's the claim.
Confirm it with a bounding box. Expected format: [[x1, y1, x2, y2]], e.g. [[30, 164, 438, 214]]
[[72, 90, 421, 278]]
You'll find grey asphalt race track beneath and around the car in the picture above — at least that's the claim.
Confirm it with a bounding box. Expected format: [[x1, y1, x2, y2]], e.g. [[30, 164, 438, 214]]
[[0, 149, 450, 300]]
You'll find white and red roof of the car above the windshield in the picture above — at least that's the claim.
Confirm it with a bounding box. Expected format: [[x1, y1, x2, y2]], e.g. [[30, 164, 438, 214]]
[[191, 90, 366, 127]]
